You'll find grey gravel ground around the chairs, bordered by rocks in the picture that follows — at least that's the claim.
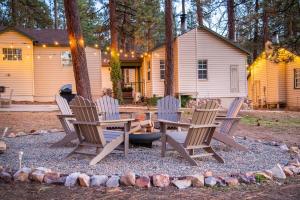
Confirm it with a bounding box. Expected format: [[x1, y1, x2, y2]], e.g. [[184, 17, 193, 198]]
[[0, 133, 289, 176]]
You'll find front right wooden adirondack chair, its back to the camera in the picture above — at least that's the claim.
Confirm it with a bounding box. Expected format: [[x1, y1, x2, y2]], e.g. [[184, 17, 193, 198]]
[[159, 101, 224, 166]]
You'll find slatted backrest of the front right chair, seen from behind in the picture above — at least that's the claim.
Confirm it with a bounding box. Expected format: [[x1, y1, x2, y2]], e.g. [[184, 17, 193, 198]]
[[184, 101, 219, 148]]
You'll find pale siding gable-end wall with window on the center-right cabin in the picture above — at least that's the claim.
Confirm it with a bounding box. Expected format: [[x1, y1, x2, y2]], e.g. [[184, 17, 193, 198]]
[[178, 29, 247, 98]]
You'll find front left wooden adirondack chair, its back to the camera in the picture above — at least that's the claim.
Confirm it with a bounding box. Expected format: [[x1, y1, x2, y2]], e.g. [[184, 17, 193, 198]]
[[69, 96, 132, 165]]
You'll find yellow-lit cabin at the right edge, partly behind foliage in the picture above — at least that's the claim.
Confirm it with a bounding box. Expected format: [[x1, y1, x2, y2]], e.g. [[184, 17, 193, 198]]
[[248, 48, 300, 109]]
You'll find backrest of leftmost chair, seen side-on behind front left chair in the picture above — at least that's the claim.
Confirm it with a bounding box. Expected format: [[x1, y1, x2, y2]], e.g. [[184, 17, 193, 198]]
[[55, 95, 74, 132]]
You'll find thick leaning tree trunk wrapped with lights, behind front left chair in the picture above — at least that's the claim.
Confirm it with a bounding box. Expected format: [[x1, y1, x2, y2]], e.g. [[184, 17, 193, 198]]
[[64, 0, 92, 100]]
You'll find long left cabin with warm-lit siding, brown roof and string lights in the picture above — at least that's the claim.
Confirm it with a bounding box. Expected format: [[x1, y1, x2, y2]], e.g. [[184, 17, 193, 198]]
[[0, 27, 102, 102]]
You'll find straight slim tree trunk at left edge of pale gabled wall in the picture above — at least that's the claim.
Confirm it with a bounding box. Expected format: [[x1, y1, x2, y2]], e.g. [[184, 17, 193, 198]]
[[165, 0, 174, 96]]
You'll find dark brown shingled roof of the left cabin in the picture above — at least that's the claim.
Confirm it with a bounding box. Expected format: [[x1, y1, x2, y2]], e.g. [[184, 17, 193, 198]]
[[0, 26, 69, 46]]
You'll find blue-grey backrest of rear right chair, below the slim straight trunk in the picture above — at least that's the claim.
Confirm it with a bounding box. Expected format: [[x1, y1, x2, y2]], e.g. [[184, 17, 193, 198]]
[[157, 96, 180, 122]]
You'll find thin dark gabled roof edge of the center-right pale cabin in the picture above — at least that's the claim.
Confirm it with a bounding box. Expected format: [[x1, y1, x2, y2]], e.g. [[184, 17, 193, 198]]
[[150, 25, 250, 55]]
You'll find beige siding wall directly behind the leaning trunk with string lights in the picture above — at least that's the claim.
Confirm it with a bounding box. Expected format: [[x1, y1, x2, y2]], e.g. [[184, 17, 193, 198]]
[[34, 47, 102, 102]]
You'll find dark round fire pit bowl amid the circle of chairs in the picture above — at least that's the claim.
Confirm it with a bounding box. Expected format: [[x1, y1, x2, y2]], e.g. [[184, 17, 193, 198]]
[[129, 120, 161, 148]]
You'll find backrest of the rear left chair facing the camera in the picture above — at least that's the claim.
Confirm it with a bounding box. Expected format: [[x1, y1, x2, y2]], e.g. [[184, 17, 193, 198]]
[[96, 95, 120, 120]]
